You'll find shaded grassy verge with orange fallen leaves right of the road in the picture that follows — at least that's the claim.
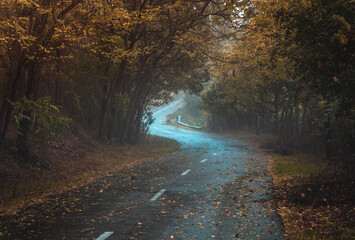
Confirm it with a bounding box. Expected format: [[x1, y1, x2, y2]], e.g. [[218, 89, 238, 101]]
[[270, 154, 355, 240]]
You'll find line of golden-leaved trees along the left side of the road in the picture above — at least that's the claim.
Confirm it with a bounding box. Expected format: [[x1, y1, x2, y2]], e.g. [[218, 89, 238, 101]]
[[0, 0, 231, 161]]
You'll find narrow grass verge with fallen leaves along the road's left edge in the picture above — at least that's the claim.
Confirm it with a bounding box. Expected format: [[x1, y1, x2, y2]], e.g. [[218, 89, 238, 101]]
[[0, 136, 180, 214]]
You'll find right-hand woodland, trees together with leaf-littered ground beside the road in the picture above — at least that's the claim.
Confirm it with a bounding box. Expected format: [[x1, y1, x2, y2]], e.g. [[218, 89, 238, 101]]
[[201, 0, 355, 239]]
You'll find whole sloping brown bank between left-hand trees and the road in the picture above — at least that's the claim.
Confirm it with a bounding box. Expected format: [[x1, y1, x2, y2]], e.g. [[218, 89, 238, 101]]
[[0, 128, 180, 214]]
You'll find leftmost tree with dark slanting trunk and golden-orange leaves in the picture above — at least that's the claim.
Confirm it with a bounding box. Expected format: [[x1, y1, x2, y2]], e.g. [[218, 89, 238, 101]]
[[0, 0, 82, 155]]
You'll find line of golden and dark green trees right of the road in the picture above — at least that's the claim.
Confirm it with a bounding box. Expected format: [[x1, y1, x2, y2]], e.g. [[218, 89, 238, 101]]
[[203, 0, 355, 160]]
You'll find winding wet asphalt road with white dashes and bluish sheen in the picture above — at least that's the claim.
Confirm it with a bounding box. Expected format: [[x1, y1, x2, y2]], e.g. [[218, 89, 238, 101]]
[[0, 100, 283, 240]]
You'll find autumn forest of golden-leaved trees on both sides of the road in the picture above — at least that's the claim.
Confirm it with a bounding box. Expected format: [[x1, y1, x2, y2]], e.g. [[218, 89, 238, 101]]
[[0, 0, 355, 239]]
